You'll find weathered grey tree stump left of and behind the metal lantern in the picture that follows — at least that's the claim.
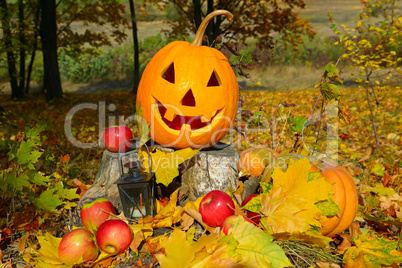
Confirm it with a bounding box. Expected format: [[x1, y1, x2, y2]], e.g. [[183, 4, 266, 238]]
[[70, 150, 138, 226]]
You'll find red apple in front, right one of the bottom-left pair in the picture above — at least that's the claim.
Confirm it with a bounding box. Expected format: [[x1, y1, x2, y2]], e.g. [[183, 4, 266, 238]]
[[96, 219, 133, 254]]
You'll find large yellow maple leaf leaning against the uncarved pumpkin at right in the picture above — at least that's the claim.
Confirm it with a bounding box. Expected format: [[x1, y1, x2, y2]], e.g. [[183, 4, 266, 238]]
[[260, 157, 332, 233]]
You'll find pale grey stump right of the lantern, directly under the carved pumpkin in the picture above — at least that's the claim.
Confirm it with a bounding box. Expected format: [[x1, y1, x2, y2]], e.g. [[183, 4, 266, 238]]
[[181, 144, 239, 202]]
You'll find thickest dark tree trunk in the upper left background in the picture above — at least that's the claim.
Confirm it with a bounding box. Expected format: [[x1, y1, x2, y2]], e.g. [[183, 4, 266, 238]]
[[40, 0, 63, 101]]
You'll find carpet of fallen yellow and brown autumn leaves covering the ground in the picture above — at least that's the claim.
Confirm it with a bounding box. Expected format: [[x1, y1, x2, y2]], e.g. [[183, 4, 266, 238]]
[[0, 87, 402, 268]]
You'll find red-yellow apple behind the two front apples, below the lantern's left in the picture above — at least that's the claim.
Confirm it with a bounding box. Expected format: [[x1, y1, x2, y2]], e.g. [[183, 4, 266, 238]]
[[80, 198, 116, 233]]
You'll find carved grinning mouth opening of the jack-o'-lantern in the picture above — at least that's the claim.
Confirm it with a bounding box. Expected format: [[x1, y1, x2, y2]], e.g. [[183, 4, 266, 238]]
[[155, 99, 223, 130]]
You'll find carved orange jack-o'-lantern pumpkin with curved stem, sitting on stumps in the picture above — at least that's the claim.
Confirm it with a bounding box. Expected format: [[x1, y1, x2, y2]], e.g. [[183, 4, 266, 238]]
[[137, 10, 239, 149]]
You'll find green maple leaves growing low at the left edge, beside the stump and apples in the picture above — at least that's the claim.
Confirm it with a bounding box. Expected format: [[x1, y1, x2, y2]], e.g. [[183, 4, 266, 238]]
[[0, 125, 79, 218]]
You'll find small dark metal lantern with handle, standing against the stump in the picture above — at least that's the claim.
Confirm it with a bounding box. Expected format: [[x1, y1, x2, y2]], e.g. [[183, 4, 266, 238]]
[[115, 139, 155, 220]]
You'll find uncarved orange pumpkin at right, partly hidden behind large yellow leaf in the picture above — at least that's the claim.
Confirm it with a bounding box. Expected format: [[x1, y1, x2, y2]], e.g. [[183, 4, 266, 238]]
[[261, 154, 358, 237]]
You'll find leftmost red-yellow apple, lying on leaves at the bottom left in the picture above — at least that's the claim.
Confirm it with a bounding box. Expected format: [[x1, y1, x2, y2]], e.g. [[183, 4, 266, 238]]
[[58, 228, 99, 265]]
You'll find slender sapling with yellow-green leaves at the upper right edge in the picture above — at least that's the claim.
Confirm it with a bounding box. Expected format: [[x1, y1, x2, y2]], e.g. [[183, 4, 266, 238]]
[[330, 0, 402, 150]]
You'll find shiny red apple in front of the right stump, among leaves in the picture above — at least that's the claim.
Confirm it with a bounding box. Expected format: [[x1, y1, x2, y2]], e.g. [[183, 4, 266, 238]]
[[199, 190, 235, 227]]
